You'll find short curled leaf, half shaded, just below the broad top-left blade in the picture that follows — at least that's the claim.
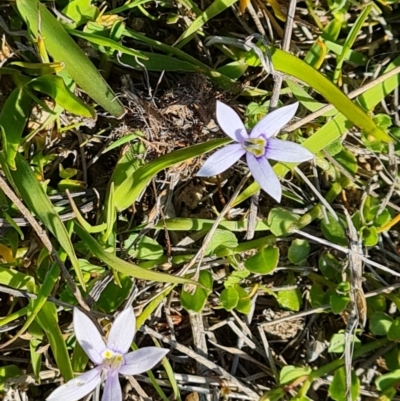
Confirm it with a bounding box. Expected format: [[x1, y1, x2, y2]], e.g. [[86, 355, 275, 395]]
[[26, 75, 96, 118]]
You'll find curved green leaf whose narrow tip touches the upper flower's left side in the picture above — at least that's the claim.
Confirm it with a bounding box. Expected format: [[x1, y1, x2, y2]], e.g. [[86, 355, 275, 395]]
[[114, 139, 230, 211]]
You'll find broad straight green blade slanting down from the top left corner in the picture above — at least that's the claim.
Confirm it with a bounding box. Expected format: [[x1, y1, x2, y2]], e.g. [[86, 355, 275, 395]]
[[16, 0, 125, 117]]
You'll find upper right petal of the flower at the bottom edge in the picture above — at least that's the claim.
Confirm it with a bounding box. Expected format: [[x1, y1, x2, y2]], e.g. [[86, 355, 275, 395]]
[[107, 307, 136, 354]]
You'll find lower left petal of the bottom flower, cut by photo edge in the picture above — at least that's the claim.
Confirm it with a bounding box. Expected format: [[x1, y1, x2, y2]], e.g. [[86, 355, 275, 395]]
[[46, 366, 102, 401]]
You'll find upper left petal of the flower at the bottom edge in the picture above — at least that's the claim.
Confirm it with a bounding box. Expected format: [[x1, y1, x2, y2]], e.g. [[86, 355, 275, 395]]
[[74, 308, 106, 365]]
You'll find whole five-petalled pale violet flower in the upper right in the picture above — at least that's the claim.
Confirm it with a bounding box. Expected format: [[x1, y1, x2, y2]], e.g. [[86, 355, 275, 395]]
[[197, 101, 314, 202]]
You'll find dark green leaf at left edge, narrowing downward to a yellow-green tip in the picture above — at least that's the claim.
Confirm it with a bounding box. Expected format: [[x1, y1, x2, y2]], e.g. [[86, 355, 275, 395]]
[[0, 88, 32, 170]]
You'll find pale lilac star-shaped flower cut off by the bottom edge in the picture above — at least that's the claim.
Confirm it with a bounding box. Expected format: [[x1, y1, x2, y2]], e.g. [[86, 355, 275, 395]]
[[46, 307, 169, 401]]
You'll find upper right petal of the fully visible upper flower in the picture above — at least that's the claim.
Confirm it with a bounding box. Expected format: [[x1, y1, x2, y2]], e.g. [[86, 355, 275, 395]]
[[250, 102, 299, 138]]
